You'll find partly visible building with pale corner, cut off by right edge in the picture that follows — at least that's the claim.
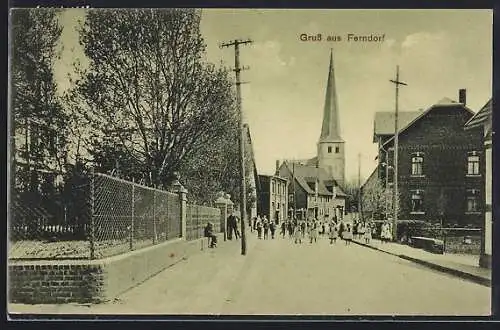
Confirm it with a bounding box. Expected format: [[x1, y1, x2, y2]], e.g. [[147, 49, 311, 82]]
[[465, 99, 493, 268]]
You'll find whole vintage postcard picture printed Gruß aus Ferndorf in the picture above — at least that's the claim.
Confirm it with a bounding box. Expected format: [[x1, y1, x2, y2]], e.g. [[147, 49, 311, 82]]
[[8, 8, 493, 317]]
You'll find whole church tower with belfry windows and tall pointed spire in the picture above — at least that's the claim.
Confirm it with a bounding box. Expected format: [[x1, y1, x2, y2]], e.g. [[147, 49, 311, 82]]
[[318, 51, 345, 187]]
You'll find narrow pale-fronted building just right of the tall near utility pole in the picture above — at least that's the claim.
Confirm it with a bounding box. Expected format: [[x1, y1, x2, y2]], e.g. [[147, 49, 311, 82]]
[[257, 175, 288, 224]]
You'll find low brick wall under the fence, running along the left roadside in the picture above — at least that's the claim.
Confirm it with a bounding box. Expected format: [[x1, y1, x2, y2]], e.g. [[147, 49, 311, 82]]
[[8, 234, 222, 304]]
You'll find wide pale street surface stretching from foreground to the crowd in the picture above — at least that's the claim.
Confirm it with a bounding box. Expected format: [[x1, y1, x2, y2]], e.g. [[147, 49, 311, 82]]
[[9, 233, 490, 315]]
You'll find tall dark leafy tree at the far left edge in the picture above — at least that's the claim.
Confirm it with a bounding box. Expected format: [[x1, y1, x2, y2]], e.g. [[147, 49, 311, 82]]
[[10, 9, 67, 190]]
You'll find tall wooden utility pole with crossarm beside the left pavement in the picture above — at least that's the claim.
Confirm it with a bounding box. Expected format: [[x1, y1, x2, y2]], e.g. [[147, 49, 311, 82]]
[[220, 39, 253, 255]]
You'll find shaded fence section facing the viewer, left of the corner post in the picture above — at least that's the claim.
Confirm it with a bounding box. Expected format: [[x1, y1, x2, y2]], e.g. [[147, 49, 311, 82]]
[[8, 168, 91, 259]]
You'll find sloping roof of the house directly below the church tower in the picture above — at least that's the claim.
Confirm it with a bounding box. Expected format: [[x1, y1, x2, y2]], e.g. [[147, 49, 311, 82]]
[[284, 161, 347, 197]]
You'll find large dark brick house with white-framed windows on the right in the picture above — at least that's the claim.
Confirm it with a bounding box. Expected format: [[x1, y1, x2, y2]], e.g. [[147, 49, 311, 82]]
[[374, 93, 485, 226]]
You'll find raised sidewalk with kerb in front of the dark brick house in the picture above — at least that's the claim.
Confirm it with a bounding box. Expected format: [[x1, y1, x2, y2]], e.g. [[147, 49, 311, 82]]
[[353, 239, 491, 287]]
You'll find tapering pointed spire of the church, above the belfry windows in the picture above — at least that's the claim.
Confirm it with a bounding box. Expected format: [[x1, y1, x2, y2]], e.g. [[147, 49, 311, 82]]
[[319, 49, 343, 142]]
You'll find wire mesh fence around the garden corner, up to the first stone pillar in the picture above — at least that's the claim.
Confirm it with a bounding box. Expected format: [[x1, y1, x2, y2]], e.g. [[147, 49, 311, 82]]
[[8, 172, 189, 260]]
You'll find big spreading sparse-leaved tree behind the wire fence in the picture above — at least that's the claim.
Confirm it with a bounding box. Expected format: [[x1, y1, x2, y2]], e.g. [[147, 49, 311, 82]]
[[73, 9, 239, 187]]
